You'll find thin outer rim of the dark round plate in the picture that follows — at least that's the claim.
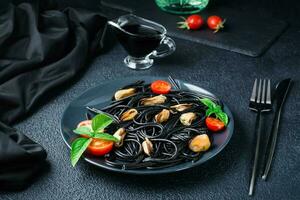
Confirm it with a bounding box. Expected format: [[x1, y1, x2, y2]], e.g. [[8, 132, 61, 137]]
[[60, 76, 234, 175]]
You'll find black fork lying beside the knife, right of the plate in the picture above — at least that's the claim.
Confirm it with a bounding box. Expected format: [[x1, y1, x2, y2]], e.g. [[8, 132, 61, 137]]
[[249, 79, 272, 196]]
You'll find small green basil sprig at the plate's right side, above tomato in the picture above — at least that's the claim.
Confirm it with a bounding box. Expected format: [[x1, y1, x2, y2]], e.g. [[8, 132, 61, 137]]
[[200, 98, 229, 126]]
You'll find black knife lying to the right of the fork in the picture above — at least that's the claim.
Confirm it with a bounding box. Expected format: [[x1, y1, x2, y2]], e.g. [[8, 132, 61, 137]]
[[262, 78, 292, 180]]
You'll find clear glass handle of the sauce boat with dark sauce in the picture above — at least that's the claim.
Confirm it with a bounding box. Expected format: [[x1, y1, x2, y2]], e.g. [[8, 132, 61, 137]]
[[149, 37, 176, 58]]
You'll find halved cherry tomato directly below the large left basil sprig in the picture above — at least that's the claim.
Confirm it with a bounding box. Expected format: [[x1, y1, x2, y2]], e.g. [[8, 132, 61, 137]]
[[87, 139, 114, 156]]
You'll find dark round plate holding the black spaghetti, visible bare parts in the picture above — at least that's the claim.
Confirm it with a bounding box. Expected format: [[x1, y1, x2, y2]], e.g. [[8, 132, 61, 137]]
[[61, 76, 234, 174]]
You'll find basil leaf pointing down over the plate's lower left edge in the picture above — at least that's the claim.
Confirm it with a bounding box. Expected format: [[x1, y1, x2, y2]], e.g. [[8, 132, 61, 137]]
[[71, 138, 93, 167]]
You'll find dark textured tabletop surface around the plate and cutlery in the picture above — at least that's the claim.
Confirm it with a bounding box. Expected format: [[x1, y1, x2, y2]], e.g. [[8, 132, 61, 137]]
[[0, 0, 300, 200]]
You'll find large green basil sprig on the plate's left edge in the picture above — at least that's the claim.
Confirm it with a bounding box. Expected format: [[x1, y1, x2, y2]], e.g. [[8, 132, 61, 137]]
[[71, 114, 119, 167]]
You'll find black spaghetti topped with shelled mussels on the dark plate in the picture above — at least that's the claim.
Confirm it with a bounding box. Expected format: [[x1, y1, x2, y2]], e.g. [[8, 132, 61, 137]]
[[87, 81, 222, 169]]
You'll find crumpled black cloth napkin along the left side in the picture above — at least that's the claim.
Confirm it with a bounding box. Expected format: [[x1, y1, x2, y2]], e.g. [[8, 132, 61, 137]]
[[0, 0, 106, 190]]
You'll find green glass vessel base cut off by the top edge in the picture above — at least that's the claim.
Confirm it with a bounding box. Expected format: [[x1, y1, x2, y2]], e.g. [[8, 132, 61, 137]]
[[155, 0, 209, 14]]
